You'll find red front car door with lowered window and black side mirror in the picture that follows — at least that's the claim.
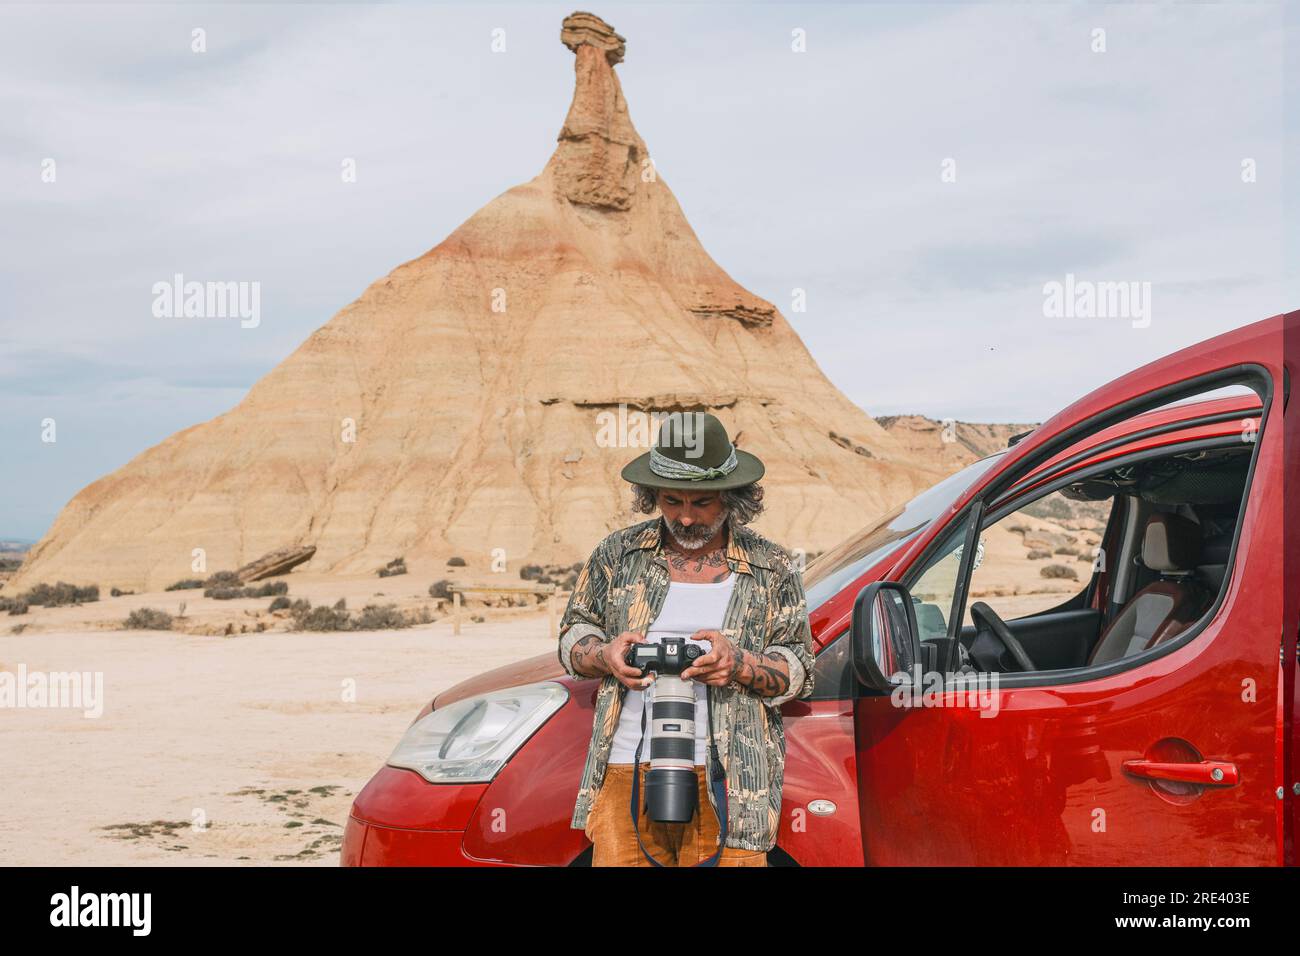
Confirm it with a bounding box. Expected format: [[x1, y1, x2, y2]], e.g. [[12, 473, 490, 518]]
[[853, 313, 1300, 866]]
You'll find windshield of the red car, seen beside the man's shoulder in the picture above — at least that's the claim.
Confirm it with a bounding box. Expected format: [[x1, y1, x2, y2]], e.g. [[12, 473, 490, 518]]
[[803, 451, 1006, 611]]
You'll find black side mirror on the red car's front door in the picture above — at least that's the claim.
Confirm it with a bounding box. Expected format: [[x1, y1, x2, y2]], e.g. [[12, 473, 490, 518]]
[[853, 581, 920, 693]]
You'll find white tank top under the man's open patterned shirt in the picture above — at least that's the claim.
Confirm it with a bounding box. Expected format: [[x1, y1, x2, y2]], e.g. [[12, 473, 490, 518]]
[[610, 572, 736, 766]]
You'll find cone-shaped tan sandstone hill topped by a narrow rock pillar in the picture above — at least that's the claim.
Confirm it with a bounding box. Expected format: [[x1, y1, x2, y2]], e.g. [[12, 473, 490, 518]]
[[7, 13, 953, 593]]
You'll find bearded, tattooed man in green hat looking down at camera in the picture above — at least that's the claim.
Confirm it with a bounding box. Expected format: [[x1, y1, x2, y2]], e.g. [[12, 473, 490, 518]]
[[559, 412, 813, 866]]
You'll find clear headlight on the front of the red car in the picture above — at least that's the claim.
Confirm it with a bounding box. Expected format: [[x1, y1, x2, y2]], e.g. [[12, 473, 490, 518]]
[[389, 680, 568, 783]]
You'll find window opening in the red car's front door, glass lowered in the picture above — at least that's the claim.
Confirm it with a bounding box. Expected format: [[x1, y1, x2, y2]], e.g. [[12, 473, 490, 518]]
[[946, 377, 1258, 671]]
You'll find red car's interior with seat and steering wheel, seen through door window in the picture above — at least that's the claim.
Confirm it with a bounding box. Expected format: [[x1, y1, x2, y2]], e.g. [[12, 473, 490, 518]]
[[913, 442, 1253, 672]]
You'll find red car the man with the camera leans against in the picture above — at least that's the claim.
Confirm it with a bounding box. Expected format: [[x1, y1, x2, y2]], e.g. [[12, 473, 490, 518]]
[[342, 312, 1300, 866]]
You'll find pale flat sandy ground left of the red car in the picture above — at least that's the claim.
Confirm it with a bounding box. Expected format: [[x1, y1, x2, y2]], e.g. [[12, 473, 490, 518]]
[[0, 613, 555, 866]]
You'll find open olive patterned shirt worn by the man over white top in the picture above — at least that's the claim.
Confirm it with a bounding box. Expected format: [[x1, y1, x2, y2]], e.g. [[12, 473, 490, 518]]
[[559, 518, 813, 851]]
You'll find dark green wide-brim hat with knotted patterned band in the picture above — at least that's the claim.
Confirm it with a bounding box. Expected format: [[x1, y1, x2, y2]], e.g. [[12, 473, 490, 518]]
[[623, 411, 764, 492]]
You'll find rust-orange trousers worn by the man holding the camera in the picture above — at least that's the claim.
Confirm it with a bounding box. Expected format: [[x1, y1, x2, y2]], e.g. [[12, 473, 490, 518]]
[[585, 761, 767, 866]]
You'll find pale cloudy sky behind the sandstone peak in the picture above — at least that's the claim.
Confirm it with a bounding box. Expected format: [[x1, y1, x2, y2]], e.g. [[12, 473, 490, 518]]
[[0, 3, 1300, 540]]
